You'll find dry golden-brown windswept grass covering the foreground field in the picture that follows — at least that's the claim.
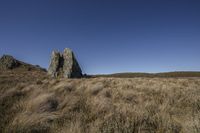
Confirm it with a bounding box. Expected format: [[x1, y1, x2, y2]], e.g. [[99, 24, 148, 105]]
[[0, 69, 200, 133]]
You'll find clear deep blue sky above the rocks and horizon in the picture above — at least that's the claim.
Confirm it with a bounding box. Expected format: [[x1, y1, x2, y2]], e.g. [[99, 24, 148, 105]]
[[0, 0, 200, 74]]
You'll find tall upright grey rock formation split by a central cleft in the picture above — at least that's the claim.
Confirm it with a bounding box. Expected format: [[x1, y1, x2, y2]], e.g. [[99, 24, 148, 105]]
[[48, 48, 82, 78]]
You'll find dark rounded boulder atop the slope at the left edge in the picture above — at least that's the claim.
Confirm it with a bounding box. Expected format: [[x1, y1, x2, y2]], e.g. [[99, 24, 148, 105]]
[[0, 55, 20, 70]]
